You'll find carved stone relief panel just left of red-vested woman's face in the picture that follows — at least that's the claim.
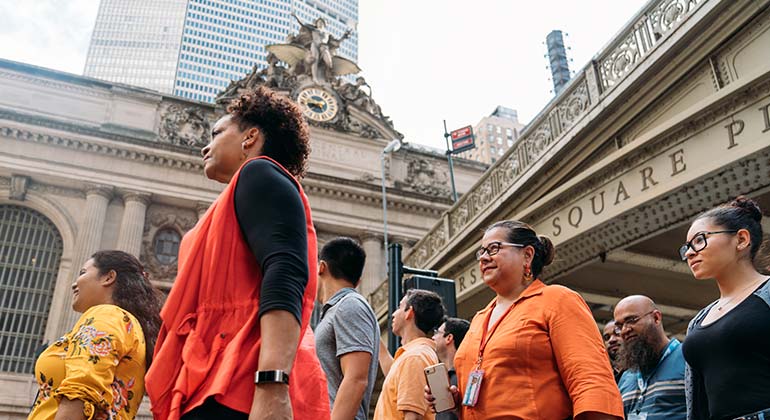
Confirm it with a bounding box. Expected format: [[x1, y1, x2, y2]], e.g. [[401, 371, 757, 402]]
[[160, 104, 210, 148]]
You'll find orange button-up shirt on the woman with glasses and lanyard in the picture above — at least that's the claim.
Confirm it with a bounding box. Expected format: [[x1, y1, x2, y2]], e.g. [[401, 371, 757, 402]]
[[455, 280, 623, 420]]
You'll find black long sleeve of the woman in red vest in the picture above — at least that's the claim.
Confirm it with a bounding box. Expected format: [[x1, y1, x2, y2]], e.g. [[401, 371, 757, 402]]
[[235, 159, 309, 323]]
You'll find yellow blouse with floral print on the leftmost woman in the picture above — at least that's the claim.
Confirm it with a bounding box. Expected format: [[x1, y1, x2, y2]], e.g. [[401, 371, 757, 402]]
[[28, 305, 146, 420]]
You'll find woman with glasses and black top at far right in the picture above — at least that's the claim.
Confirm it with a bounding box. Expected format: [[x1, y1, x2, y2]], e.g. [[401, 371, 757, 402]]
[[679, 197, 770, 420]]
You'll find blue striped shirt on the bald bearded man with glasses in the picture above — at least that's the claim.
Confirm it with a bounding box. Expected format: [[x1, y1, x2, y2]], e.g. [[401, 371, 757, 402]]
[[618, 338, 687, 420]]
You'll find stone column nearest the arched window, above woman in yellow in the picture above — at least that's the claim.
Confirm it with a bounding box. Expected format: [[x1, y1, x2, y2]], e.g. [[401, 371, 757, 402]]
[[58, 185, 113, 334]]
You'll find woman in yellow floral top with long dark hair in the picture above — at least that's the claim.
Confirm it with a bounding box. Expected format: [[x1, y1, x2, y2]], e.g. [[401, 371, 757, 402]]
[[29, 251, 162, 420]]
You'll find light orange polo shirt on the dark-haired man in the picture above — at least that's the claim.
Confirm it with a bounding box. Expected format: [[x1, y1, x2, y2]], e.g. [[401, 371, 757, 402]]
[[374, 337, 438, 420]]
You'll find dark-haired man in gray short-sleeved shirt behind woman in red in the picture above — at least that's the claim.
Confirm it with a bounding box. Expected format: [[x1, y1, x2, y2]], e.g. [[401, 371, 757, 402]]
[[315, 238, 380, 420]]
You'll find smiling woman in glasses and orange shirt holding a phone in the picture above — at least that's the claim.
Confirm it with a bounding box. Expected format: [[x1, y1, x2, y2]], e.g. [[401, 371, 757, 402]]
[[425, 221, 623, 420]]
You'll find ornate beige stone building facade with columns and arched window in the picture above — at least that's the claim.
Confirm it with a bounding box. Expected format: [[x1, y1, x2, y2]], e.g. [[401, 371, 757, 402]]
[[0, 55, 485, 420]]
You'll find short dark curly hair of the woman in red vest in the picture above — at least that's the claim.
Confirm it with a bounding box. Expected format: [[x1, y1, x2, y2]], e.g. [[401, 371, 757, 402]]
[[227, 86, 310, 178]]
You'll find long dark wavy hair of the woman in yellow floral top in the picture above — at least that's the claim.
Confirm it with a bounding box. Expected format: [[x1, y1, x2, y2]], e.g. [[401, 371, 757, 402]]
[[91, 251, 163, 368]]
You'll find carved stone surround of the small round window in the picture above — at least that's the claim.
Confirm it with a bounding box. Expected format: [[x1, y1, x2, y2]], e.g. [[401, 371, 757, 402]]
[[141, 205, 198, 281]]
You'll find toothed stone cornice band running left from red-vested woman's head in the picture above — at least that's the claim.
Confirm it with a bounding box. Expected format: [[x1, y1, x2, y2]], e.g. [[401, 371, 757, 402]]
[[0, 124, 203, 173]]
